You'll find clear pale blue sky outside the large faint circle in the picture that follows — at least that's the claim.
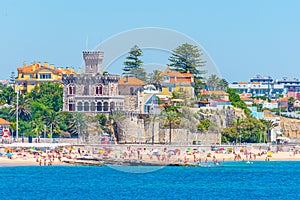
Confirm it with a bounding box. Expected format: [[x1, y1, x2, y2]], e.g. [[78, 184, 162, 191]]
[[0, 0, 300, 82]]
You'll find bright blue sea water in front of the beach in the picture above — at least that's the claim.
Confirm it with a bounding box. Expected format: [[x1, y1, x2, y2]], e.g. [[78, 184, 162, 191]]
[[0, 161, 300, 199]]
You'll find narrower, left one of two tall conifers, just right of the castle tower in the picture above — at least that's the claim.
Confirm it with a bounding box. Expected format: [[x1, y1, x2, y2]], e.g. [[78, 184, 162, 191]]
[[123, 45, 147, 81]]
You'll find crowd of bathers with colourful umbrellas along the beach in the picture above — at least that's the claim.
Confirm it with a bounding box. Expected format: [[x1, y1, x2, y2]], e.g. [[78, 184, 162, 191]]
[[0, 145, 300, 166]]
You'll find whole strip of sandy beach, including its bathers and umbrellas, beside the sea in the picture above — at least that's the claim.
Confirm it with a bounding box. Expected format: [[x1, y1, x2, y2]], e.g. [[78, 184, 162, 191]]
[[0, 146, 300, 167]]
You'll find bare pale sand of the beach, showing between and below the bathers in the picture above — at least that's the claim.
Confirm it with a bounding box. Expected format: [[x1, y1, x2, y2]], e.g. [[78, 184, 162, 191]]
[[0, 147, 300, 167]]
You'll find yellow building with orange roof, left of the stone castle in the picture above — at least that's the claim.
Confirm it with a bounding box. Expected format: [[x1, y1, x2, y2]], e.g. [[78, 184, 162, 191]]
[[15, 62, 76, 94]]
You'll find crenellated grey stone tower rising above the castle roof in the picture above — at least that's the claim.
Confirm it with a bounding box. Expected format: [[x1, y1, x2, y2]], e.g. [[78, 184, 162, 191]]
[[82, 51, 104, 74]]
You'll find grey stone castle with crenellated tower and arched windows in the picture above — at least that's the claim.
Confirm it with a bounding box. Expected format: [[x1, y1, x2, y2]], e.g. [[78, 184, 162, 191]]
[[62, 51, 124, 113]]
